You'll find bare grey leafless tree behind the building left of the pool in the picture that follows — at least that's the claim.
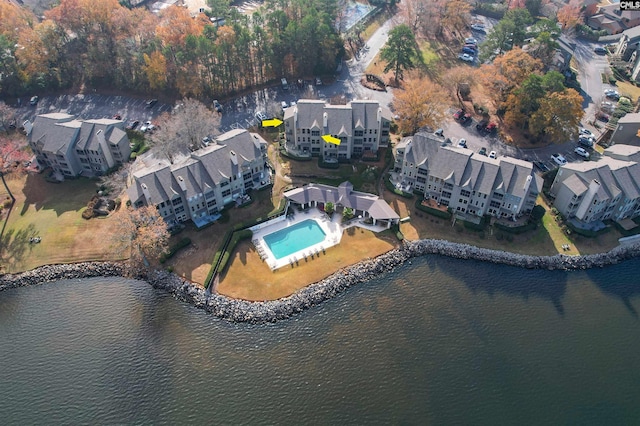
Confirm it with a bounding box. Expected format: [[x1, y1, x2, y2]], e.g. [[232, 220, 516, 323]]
[[151, 98, 220, 163]]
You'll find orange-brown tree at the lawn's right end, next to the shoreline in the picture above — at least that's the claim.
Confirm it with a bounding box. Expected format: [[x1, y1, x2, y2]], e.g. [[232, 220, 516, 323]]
[[114, 206, 169, 267]]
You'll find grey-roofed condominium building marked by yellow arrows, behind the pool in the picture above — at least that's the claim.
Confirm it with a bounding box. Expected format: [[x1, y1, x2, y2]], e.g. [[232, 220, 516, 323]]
[[284, 99, 391, 160]]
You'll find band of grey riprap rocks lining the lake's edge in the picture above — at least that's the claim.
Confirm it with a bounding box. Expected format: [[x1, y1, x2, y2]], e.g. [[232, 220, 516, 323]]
[[0, 240, 640, 324]]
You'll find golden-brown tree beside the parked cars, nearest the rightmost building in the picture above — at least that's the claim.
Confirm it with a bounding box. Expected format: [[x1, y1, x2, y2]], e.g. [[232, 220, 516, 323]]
[[529, 89, 584, 143]]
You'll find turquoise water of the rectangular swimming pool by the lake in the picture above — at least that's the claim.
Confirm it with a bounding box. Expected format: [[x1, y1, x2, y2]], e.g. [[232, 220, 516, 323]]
[[264, 219, 325, 259]]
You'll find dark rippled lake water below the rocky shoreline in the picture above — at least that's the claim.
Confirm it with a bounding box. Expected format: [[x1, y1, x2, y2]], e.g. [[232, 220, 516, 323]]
[[0, 256, 640, 425]]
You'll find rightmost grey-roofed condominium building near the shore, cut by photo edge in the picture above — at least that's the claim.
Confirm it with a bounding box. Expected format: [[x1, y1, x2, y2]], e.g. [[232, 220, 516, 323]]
[[550, 144, 640, 224]]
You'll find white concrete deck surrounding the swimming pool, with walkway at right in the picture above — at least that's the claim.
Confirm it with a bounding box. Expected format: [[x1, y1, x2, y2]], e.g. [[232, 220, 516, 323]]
[[250, 208, 386, 271]]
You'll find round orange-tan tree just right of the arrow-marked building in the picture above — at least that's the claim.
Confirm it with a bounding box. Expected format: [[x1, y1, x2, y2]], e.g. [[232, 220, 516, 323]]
[[393, 77, 449, 134]]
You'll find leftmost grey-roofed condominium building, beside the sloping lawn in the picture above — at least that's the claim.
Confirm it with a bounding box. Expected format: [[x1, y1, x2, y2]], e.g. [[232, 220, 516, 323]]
[[24, 113, 131, 179]]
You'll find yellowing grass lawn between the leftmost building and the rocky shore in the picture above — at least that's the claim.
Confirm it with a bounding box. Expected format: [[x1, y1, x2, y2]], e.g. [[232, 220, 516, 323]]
[[0, 174, 127, 272]]
